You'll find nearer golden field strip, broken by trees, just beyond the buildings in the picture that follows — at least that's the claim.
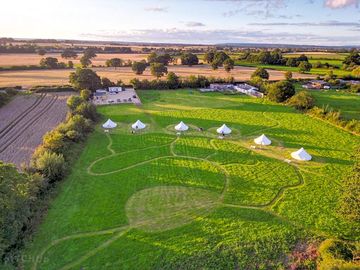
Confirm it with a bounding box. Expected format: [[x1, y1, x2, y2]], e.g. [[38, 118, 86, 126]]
[[0, 65, 314, 87]]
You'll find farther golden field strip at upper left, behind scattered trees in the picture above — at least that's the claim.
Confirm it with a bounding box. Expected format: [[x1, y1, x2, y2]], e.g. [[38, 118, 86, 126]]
[[0, 53, 147, 67]]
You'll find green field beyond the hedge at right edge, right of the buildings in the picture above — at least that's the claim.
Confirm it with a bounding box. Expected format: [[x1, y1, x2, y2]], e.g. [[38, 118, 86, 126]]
[[296, 84, 360, 120]]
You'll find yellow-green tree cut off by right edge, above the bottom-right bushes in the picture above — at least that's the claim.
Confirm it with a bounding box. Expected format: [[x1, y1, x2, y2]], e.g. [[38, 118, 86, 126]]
[[339, 148, 360, 223]]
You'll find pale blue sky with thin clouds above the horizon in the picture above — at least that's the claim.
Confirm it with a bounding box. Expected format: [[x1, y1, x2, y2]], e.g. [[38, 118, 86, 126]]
[[0, 0, 360, 46]]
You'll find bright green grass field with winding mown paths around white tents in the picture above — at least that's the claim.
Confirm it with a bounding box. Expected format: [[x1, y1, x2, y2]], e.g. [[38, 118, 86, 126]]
[[24, 90, 360, 270]]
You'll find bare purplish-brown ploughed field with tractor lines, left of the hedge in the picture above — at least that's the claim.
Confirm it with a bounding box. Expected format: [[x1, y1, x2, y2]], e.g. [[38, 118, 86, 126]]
[[0, 94, 68, 167]]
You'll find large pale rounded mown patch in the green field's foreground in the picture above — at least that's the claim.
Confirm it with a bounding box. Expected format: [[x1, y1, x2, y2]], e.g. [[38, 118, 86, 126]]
[[126, 186, 219, 231]]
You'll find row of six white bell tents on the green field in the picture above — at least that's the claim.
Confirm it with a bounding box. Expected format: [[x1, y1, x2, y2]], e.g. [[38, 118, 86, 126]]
[[103, 119, 312, 161]]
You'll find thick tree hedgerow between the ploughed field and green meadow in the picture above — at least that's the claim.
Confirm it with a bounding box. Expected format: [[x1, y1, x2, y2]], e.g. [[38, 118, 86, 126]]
[[0, 90, 98, 265]]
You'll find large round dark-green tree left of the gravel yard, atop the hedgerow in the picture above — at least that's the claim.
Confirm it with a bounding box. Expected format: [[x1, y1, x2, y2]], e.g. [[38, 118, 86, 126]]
[[69, 68, 101, 91]]
